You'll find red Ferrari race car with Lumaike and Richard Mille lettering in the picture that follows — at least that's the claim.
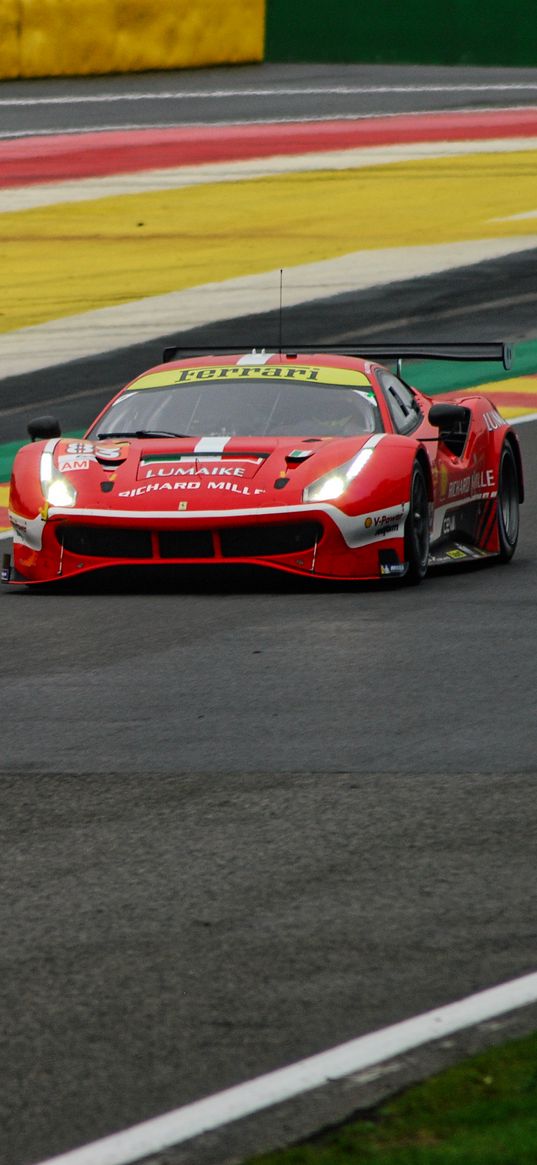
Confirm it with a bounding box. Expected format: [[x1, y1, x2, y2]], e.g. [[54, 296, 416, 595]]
[[2, 344, 523, 584]]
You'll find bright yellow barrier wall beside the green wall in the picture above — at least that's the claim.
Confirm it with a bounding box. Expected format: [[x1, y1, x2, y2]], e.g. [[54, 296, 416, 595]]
[[0, 0, 266, 77]]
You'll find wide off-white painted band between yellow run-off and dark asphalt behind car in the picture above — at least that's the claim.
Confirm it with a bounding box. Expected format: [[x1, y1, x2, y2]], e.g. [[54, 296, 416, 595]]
[[0, 234, 537, 379]]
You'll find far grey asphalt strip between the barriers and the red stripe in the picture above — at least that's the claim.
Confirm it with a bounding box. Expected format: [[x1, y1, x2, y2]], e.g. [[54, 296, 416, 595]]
[[5, 64, 537, 136]]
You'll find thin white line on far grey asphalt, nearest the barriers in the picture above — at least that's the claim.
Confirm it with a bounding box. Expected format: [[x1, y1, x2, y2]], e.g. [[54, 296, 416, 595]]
[[0, 79, 537, 106]]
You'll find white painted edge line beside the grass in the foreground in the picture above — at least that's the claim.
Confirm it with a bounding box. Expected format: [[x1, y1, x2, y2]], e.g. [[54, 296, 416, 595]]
[[31, 973, 537, 1165]]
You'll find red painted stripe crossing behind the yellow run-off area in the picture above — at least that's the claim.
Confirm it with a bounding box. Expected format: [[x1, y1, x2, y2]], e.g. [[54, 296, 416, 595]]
[[0, 107, 537, 188]]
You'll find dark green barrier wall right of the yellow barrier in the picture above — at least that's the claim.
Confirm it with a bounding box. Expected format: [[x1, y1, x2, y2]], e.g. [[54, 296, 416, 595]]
[[266, 0, 537, 65]]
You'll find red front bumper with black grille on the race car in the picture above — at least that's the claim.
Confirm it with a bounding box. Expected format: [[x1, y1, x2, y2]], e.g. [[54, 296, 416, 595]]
[[4, 504, 408, 584]]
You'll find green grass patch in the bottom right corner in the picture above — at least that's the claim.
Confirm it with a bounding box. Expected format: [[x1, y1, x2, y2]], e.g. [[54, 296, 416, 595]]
[[248, 1035, 537, 1165]]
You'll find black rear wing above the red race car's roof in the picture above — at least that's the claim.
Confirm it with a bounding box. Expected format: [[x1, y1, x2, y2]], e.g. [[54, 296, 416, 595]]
[[162, 340, 513, 370]]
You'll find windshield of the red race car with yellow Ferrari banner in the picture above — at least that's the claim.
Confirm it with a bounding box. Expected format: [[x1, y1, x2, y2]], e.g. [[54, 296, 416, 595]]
[[89, 366, 382, 437]]
